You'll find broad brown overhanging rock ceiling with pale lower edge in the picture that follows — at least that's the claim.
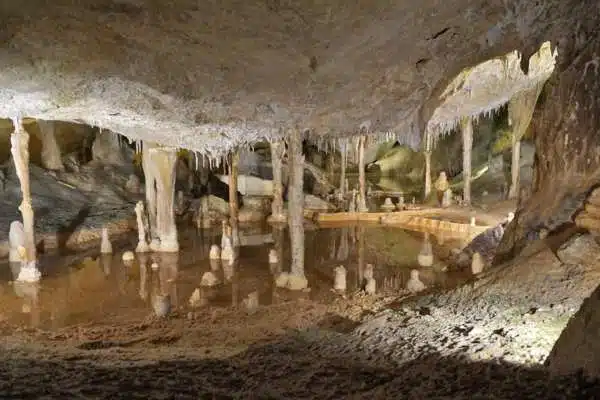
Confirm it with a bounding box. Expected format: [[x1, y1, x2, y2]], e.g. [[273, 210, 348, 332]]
[[0, 0, 589, 154]]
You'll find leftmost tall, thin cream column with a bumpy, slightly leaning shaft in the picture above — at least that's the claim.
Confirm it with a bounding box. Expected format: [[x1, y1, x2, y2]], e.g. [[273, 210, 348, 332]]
[[10, 118, 41, 282]]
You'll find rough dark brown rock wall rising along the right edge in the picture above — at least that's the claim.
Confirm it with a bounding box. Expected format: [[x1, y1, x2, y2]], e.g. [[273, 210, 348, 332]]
[[495, 18, 600, 263]]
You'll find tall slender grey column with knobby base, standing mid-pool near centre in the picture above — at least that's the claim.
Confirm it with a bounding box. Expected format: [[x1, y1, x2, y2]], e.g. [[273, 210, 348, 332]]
[[287, 131, 308, 290]]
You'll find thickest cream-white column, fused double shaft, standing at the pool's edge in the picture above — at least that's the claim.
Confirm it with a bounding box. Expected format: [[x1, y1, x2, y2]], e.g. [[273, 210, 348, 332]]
[[148, 147, 179, 252]]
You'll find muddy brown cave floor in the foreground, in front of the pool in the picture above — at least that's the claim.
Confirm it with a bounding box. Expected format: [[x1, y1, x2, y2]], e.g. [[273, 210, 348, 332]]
[[0, 185, 600, 399]]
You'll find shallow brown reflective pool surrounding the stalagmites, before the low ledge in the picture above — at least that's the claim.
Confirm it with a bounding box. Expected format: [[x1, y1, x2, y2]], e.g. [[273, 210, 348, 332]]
[[0, 225, 470, 329]]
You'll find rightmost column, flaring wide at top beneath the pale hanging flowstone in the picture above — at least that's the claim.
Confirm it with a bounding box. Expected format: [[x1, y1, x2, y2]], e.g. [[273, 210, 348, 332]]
[[508, 82, 544, 199]]
